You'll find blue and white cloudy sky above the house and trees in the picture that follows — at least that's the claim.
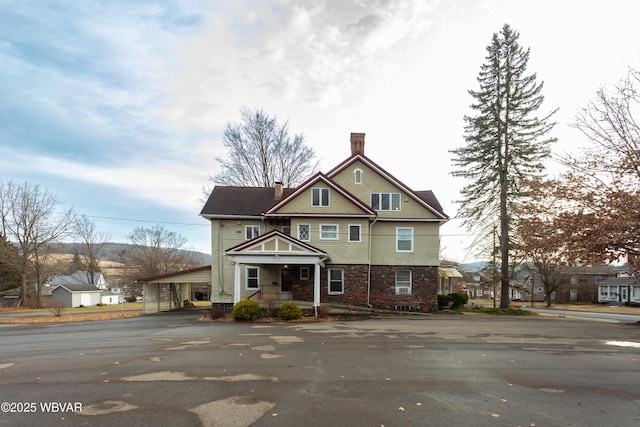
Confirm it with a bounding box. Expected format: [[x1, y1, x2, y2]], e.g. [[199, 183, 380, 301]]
[[0, 0, 640, 261]]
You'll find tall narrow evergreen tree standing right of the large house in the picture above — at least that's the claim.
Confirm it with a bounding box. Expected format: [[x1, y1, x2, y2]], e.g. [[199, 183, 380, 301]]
[[451, 24, 557, 308]]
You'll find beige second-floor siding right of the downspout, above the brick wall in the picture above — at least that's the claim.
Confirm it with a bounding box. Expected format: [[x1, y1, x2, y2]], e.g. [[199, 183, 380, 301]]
[[371, 221, 440, 265]]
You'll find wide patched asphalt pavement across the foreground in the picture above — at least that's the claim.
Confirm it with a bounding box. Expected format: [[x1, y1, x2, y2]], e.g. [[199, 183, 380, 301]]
[[0, 312, 640, 426]]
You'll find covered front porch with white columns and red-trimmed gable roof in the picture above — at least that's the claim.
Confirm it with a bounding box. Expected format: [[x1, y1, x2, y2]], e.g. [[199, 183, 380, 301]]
[[225, 230, 327, 307]]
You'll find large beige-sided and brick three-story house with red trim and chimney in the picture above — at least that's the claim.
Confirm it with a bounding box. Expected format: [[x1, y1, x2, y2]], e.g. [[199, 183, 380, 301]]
[[201, 133, 448, 310]]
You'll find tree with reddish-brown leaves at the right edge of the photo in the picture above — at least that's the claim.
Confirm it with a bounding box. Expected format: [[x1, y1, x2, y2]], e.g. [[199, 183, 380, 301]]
[[561, 69, 640, 268]]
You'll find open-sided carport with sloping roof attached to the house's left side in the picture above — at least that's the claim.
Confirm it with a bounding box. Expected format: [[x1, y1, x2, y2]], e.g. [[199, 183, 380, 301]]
[[136, 265, 211, 314]]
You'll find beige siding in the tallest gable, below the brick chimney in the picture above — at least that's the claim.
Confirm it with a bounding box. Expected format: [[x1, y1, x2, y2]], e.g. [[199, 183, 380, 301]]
[[333, 161, 436, 218]]
